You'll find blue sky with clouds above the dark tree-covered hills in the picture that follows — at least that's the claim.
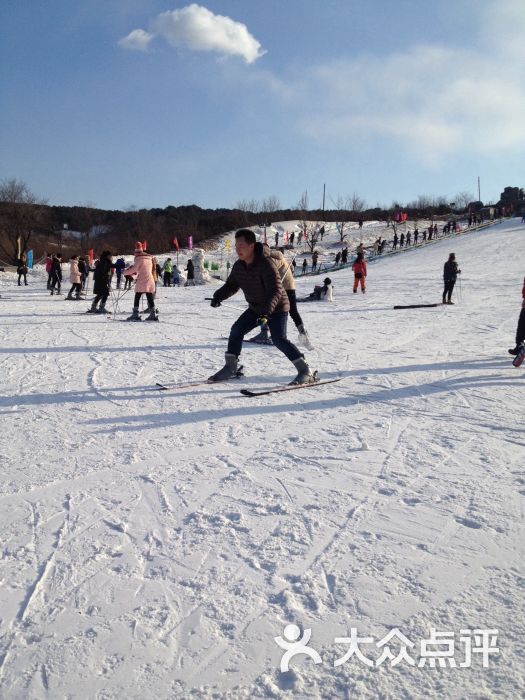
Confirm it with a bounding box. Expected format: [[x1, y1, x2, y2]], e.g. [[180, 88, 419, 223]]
[[0, 0, 525, 209]]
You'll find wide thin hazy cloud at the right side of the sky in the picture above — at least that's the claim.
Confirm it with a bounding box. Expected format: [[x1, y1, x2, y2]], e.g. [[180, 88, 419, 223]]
[[260, 0, 525, 167]]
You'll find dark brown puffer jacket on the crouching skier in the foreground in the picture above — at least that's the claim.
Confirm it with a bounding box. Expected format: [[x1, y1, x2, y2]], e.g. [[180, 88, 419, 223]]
[[213, 243, 290, 316]]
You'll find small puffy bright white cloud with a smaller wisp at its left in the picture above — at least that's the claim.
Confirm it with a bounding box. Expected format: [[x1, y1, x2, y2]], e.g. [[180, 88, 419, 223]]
[[119, 3, 266, 63]]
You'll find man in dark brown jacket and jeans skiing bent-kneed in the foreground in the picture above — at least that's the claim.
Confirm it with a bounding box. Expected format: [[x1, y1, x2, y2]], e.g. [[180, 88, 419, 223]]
[[209, 229, 316, 384]]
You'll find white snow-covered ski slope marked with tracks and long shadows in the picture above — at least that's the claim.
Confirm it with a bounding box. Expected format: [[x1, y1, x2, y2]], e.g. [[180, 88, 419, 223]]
[[0, 219, 525, 700]]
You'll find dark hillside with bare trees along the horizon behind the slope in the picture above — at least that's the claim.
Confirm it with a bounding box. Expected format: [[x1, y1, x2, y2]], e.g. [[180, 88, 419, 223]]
[[0, 179, 523, 263]]
